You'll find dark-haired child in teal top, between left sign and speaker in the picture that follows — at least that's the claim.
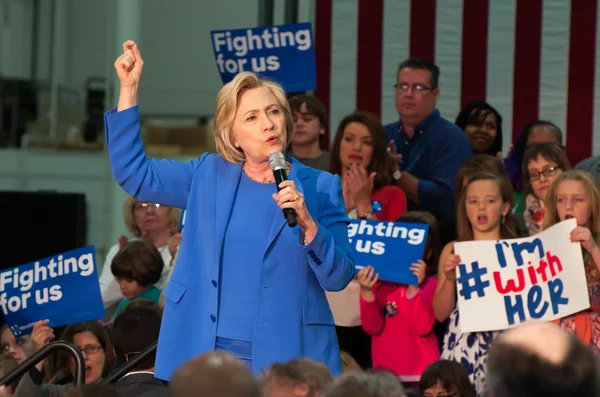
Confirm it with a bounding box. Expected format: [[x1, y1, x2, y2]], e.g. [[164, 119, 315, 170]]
[[110, 240, 164, 318]]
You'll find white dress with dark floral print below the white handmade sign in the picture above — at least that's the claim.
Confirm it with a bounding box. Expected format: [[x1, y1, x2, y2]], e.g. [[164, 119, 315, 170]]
[[441, 309, 500, 397]]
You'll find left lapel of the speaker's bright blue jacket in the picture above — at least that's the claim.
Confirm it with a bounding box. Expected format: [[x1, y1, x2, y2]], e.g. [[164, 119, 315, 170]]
[[215, 160, 242, 263]]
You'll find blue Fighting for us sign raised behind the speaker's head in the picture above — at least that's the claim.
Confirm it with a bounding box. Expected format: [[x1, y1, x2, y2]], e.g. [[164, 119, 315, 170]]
[[211, 23, 317, 92]]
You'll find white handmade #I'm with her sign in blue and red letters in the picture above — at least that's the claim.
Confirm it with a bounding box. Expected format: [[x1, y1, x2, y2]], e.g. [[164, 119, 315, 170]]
[[454, 219, 590, 332]]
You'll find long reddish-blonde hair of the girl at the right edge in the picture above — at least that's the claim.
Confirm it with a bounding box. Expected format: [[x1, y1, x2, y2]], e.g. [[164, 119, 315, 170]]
[[543, 170, 600, 262]]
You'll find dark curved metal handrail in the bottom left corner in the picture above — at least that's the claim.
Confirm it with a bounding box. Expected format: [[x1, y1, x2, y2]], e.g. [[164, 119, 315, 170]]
[[0, 340, 85, 386]]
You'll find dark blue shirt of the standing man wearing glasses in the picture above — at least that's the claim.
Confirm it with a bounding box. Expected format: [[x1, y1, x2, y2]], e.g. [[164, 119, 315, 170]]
[[385, 109, 473, 220]]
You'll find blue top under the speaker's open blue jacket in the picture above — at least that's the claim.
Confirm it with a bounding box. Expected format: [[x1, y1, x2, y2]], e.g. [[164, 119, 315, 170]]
[[217, 174, 283, 341]]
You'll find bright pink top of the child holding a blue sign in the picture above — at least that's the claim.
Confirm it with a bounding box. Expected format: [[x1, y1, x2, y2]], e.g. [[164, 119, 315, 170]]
[[360, 277, 440, 382]]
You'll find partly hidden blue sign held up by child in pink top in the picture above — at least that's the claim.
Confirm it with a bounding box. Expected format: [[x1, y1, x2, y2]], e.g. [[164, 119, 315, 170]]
[[348, 220, 429, 285]]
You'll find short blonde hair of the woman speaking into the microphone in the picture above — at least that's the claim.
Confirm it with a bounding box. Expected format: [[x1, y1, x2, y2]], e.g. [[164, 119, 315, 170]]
[[213, 72, 293, 164]]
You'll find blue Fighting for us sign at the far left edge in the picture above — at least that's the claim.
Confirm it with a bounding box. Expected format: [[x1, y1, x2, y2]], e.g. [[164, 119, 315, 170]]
[[0, 246, 105, 337]]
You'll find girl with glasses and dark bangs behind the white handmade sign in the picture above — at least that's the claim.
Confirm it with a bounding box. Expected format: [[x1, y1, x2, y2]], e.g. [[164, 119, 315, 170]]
[[517, 142, 571, 236]]
